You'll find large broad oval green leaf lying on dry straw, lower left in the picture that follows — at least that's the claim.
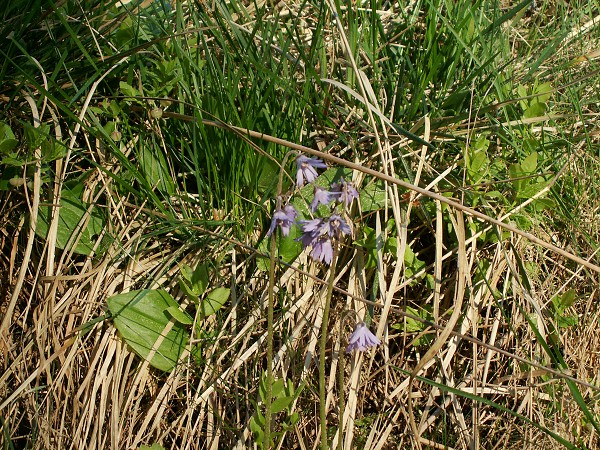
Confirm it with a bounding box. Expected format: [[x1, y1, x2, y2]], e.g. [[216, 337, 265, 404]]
[[107, 289, 189, 372]]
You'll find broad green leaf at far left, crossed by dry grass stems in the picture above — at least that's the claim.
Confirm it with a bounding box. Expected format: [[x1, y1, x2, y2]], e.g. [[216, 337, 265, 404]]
[[35, 185, 105, 255]]
